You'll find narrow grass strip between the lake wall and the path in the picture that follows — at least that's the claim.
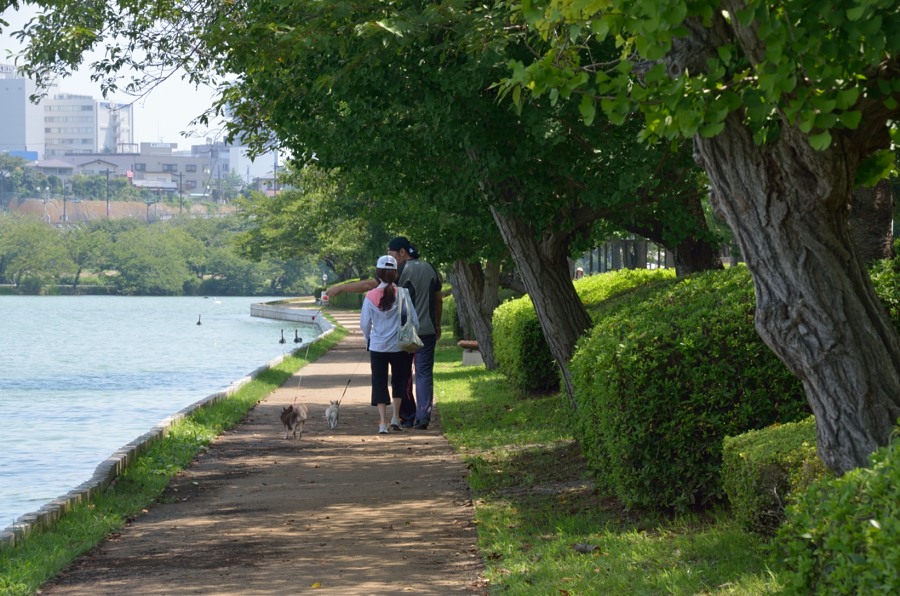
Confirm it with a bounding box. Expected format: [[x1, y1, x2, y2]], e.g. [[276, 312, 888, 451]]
[[0, 326, 347, 595]]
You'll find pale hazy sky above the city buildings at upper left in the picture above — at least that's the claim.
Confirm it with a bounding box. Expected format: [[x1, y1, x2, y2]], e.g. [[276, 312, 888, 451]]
[[0, 7, 224, 149]]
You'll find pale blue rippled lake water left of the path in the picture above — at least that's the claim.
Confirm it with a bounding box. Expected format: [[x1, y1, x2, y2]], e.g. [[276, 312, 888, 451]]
[[0, 296, 318, 529]]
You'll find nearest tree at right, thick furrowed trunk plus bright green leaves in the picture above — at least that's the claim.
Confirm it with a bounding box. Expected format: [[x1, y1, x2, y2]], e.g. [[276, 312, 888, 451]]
[[506, 0, 900, 472]]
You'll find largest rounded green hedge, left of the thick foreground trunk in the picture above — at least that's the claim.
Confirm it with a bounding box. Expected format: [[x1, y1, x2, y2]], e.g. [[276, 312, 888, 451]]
[[571, 267, 810, 510]]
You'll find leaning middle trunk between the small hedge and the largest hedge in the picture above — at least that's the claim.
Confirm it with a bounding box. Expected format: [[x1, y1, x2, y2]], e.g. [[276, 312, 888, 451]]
[[491, 207, 591, 408]]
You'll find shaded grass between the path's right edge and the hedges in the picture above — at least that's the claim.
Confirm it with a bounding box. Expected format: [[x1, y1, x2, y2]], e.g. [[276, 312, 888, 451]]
[[435, 339, 781, 595]]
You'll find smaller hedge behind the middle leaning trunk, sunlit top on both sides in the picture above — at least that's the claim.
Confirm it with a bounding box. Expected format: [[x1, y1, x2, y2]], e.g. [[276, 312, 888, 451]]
[[492, 269, 675, 393]]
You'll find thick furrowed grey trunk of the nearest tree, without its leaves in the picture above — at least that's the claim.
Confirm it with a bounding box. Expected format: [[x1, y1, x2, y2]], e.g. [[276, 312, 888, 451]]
[[695, 114, 900, 473]]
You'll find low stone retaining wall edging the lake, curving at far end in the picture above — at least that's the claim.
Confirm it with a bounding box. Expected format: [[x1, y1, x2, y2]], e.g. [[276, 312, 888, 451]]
[[0, 304, 335, 547]]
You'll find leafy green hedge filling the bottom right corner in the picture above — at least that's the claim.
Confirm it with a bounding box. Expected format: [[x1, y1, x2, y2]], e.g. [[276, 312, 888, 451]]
[[773, 430, 900, 594]]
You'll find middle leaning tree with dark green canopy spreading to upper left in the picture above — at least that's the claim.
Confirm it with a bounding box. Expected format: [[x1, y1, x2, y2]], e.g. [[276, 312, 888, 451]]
[[7, 0, 715, 400]]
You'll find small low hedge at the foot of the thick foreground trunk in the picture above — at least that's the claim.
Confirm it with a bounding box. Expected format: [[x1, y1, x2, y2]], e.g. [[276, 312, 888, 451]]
[[722, 416, 834, 536]]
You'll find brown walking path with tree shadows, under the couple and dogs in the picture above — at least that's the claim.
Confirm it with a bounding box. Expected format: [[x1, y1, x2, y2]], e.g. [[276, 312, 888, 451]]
[[41, 311, 484, 595]]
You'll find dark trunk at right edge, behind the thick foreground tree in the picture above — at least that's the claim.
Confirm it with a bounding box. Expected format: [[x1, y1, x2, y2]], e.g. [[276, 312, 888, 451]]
[[850, 180, 894, 263]]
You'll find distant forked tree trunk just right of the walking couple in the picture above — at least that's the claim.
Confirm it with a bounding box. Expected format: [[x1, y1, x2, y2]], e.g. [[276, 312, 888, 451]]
[[453, 260, 500, 370]]
